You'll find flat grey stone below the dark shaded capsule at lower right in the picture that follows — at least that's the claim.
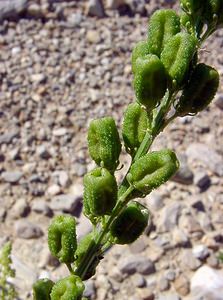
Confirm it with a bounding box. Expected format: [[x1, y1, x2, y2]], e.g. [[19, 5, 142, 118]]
[[118, 255, 155, 275]]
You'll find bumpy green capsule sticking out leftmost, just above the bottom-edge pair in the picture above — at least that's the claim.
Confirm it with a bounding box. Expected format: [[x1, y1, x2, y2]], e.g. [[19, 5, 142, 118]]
[[48, 216, 77, 263]]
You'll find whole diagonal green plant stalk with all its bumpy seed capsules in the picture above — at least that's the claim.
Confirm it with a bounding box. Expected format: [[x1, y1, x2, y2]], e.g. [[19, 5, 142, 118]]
[[33, 0, 223, 300]]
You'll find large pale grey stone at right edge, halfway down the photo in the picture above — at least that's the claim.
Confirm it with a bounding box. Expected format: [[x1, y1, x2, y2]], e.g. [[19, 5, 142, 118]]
[[186, 143, 223, 176]]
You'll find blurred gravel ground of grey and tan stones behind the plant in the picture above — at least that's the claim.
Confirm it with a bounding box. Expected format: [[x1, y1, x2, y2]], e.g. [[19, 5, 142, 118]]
[[0, 0, 223, 300]]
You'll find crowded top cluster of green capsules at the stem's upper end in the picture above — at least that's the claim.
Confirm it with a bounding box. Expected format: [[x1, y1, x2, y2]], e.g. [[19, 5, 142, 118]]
[[132, 0, 220, 119]]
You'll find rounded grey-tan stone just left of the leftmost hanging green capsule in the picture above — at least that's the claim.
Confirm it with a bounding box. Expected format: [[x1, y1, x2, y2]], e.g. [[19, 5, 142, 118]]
[[14, 219, 43, 239]]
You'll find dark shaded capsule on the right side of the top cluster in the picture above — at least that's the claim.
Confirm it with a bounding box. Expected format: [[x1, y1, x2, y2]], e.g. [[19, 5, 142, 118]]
[[176, 64, 219, 116]]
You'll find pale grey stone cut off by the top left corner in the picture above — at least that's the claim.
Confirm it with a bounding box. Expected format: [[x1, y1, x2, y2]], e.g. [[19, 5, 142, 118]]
[[0, 0, 28, 21]]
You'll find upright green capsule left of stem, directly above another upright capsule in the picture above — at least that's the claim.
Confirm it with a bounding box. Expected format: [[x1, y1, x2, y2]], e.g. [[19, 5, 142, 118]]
[[88, 117, 121, 171]]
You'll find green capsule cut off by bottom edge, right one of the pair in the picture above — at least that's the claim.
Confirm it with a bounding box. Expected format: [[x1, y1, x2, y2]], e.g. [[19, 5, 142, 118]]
[[50, 275, 84, 300]]
